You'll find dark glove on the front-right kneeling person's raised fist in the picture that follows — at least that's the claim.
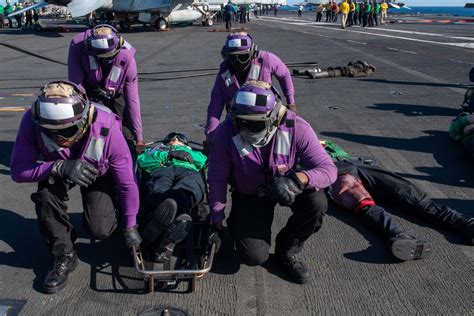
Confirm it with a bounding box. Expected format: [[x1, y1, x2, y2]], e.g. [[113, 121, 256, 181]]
[[267, 170, 304, 206]]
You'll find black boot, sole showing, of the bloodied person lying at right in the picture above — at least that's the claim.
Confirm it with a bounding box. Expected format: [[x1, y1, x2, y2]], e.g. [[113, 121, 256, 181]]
[[390, 233, 431, 261]]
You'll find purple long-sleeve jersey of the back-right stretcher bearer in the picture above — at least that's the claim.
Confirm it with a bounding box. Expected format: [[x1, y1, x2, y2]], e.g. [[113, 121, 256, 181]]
[[205, 51, 295, 141]]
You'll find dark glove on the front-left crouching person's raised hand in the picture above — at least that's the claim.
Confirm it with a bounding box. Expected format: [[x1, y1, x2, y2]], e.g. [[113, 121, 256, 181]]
[[52, 160, 99, 187]]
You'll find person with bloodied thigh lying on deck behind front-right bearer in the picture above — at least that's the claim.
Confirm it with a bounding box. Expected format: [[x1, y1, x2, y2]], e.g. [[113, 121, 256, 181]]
[[321, 140, 474, 261]]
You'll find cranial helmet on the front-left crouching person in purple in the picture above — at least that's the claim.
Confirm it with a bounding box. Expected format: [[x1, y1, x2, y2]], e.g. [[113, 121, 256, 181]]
[[31, 80, 91, 147]]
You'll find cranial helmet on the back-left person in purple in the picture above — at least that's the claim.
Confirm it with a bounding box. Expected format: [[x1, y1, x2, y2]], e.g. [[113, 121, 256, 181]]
[[87, 24, 123, 58]]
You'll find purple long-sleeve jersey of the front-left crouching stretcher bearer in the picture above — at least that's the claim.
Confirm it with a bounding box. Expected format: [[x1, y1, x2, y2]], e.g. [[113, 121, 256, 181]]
[[11, 110, 139, 227]]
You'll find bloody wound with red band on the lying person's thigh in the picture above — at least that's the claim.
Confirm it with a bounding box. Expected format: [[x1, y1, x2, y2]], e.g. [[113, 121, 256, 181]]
[[328, 174, 375, 214]]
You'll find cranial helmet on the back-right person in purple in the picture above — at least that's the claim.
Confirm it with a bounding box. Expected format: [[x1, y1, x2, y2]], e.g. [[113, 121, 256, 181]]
[[222, 32, 257, 70]]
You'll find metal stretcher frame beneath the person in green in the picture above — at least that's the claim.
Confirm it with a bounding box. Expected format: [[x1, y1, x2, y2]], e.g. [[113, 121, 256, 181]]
[[132, 141, 216, 293]]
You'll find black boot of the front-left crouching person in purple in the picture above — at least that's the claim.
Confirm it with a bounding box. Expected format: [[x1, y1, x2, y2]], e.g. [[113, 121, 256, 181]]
[[43, 250, 77, 294]]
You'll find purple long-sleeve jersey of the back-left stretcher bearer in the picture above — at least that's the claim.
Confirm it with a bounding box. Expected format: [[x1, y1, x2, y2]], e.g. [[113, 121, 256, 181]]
[[67, 31, 143, 141]]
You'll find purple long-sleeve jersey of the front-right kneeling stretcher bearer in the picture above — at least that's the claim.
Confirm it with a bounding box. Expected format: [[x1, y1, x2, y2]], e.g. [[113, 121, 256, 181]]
[[208, 117, 337, 222]]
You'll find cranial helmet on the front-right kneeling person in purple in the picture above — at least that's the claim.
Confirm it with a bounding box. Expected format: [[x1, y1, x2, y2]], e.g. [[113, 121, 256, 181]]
[[231, 81, 286, 146]]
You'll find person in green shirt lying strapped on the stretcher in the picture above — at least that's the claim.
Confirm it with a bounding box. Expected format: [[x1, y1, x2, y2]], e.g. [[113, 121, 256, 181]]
[[137, 132, 207, 262]]
